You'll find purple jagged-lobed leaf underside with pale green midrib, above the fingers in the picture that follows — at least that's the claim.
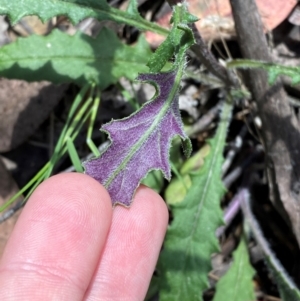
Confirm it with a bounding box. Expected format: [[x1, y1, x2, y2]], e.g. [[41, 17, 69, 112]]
[[84, 70, 188, 206]]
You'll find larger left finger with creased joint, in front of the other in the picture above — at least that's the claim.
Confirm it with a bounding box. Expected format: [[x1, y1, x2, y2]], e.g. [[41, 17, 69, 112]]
[[0, 173, 112, 301]]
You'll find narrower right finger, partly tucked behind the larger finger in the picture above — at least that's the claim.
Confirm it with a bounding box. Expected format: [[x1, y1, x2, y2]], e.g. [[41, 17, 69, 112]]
[[85, 186, 168, 301]]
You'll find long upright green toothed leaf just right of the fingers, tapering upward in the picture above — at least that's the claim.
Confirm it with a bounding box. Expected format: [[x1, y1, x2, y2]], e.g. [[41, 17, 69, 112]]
[[158, 98, 232, 301]]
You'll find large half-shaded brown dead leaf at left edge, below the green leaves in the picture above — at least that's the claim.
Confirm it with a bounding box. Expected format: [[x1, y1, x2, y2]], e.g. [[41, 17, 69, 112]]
[[0, 78, 67, 152]]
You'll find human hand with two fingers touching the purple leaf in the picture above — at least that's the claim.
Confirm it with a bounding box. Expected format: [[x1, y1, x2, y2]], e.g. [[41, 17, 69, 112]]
[[0, 173, 168, 301]]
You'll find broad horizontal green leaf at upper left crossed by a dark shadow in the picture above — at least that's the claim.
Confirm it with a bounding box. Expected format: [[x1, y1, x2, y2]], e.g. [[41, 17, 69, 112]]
[[0, 28, 151, 89]]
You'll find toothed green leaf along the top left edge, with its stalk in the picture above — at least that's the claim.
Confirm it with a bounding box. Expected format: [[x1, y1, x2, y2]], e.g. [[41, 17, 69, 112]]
[[0, 0, 168, 35]]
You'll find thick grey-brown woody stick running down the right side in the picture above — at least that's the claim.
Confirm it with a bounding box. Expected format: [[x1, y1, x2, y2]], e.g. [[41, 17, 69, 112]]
[[230, 0, 300, 245]]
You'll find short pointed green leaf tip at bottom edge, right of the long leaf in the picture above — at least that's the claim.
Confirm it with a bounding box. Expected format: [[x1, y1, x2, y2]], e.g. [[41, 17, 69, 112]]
[[213, 238, 255, 301]]
